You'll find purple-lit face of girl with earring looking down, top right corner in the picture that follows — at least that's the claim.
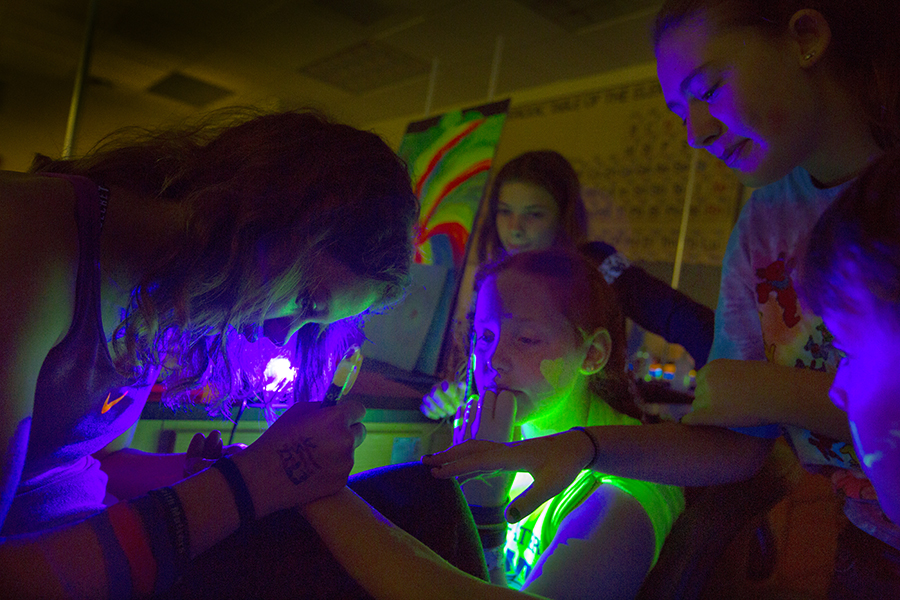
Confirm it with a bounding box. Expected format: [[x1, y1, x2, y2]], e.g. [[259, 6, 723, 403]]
[[656, 10, 877, 187]]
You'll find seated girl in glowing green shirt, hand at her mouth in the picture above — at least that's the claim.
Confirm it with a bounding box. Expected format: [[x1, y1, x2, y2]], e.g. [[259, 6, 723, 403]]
[[442, 249, 684, 598]]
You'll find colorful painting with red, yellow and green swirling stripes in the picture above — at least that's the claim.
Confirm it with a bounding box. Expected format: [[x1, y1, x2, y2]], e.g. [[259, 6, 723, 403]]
[[399, 100, 509, 268]]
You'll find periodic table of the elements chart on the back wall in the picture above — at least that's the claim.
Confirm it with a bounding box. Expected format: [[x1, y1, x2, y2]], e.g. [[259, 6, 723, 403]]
[[495, 78, 742, 267]]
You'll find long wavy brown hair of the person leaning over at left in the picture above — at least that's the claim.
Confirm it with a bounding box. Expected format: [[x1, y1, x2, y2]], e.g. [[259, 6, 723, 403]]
[[37, 109, 418, 408]]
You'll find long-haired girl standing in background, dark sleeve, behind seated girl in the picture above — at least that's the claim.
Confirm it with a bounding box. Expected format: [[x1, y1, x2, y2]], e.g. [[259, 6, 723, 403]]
[[421, 150, 713, 419]]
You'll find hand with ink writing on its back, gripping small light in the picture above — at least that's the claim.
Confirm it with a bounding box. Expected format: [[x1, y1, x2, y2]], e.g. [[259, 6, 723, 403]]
[[233, 399, 366, 516]]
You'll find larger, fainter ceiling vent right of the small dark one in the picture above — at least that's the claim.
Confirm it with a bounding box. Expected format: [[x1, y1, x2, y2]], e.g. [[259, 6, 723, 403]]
[[300, 41, 431, 94]]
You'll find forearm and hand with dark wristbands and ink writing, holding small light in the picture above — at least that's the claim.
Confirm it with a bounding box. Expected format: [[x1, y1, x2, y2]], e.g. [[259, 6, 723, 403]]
[[0, 401, 365, 598]]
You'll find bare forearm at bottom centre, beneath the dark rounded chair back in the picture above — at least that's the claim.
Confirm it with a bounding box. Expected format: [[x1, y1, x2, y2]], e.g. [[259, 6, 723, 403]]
[[300, 488, 540, 600]]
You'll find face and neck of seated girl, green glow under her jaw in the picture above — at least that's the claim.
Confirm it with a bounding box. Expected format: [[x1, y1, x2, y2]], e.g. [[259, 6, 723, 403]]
[[473, 269, 609, 430]]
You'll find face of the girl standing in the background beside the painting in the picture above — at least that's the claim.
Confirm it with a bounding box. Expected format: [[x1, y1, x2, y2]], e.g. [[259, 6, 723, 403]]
[[497, 181, 560, 254]]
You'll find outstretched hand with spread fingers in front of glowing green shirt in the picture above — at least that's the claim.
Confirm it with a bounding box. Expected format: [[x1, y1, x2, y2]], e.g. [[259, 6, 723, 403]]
[[422, 431, 594, 523]]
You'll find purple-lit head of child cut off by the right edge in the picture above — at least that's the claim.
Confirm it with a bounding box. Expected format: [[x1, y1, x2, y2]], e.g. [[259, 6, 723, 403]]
[[801, 150, 900, 524]]
